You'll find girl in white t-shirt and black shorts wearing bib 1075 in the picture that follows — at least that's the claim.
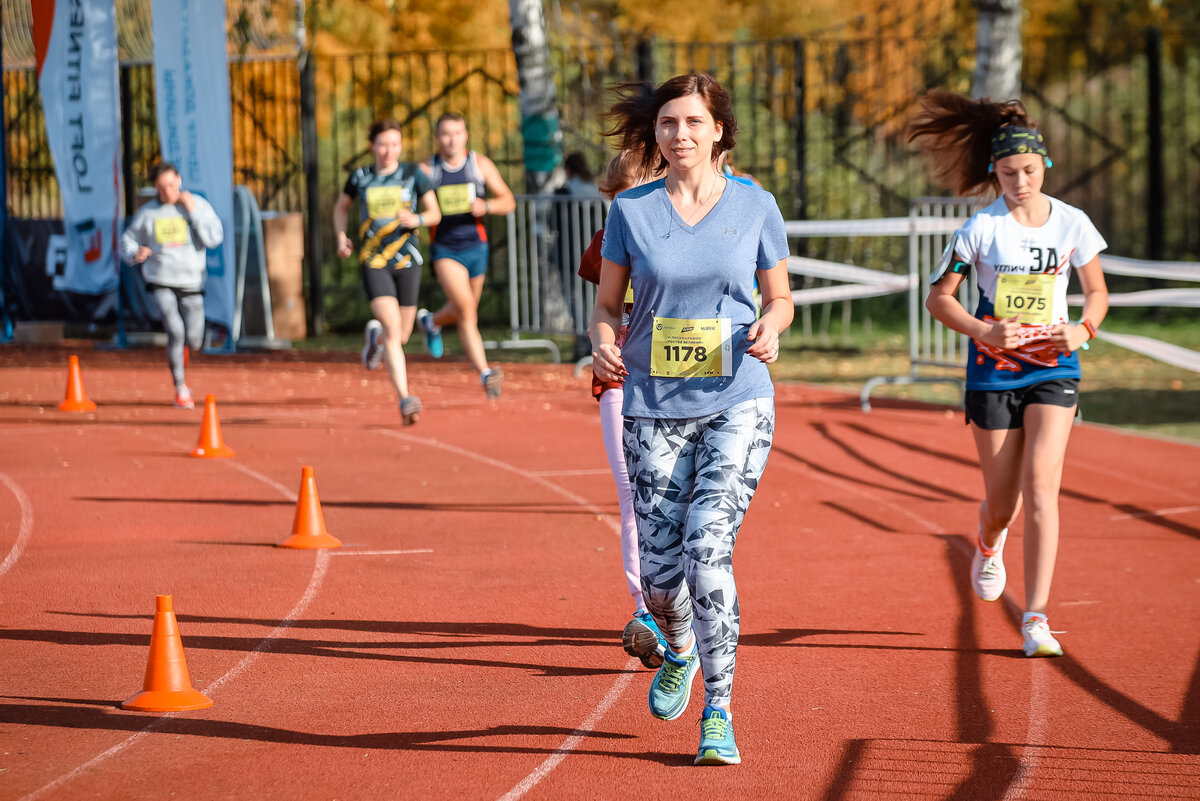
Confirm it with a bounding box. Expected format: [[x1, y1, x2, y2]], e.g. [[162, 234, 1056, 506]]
[[910, 92, 1109, 656]]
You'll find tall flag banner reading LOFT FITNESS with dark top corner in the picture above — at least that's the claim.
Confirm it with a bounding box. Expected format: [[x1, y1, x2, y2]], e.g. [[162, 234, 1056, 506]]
[[32, 0, 121, 295]]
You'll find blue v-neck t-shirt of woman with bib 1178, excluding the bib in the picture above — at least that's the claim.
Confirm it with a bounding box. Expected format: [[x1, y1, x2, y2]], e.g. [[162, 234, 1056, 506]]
[[600, 179, 787, 420]]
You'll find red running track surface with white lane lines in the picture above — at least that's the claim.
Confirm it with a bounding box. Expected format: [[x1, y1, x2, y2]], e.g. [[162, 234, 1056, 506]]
[[0, 348, 1200, 801]]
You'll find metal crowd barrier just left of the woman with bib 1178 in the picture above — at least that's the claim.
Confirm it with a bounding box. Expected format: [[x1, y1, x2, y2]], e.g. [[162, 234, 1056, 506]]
[[496, 194, 608, 365]]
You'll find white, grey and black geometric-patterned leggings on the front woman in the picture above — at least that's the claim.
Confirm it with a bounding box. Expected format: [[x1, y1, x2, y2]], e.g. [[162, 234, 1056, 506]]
[[624, 398, 775, 705]]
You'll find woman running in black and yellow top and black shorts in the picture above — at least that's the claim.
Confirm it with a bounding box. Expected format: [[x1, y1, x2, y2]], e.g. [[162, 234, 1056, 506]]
[[334, 120, 442, 426]]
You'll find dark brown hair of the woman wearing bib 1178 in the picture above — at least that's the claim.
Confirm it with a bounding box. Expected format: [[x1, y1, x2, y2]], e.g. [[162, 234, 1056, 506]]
[[604, 73, 738, 171]]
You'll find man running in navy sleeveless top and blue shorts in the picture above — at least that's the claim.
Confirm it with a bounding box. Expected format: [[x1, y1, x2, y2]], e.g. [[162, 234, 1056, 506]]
[[418, 114, 516, 398]]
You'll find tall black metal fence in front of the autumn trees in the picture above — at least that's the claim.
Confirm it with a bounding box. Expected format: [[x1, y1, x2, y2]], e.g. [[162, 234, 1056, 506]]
[[4, 30, 1200, 326]]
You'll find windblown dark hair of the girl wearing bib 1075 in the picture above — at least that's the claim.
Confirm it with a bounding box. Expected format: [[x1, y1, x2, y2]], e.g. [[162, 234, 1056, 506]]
[[908, 90, 1037, 197]]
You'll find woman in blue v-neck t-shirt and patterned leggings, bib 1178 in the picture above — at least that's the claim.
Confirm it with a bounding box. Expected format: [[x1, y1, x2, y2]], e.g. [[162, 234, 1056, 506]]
[[590, 74, 793, 765]]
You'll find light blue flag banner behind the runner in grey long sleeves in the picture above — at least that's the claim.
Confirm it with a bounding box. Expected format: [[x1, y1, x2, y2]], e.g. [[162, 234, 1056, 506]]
[[150, 0, 236, 341]]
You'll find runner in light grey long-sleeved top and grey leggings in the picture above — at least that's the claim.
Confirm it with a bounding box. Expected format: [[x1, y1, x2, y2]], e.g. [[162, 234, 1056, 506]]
[[121, 162, 224, 409]]
